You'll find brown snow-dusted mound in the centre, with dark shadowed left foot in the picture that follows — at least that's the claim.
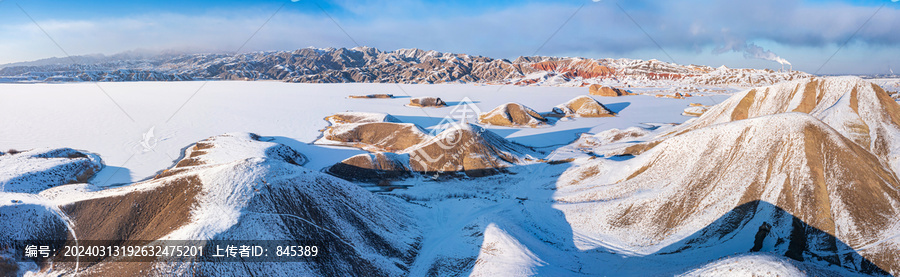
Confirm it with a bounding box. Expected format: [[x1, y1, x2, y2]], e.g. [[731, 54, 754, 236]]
[[329, 124, 537, 179]]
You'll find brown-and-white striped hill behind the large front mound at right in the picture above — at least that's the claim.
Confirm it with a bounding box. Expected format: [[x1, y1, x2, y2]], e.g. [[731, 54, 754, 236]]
[[673, 77, 900, 173]]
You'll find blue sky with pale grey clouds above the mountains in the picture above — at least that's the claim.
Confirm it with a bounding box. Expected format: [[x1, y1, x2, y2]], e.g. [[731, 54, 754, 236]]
[[0, 0, 900, 74]]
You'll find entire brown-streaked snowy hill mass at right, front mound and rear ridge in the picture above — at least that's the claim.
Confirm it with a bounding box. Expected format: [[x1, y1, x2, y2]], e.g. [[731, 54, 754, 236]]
[[555, 77, 900, 274]]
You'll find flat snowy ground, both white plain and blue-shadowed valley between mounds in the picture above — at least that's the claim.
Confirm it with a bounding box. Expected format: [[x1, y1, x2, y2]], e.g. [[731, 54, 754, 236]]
[[0, 78, 896, 276]]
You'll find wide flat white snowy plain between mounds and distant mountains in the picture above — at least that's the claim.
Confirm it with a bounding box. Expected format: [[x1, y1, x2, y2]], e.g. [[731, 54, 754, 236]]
[[0, 81, 728, 187]]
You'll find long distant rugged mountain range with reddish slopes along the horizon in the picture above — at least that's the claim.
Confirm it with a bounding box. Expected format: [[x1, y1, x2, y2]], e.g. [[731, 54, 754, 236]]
[[0, 47, 811, 86]]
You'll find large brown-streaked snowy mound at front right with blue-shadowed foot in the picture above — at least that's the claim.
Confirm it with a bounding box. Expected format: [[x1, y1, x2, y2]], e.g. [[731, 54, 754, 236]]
[[555, 112, 900, 274]]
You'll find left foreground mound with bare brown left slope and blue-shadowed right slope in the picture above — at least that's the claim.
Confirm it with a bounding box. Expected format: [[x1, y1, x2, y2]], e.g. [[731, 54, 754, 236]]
[[10, 133, 417, 276]]
